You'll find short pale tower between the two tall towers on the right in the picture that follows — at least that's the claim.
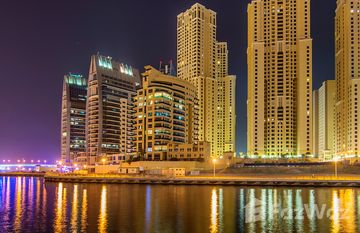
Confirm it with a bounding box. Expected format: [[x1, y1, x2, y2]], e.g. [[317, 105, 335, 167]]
[[313, 80, 336, 160]]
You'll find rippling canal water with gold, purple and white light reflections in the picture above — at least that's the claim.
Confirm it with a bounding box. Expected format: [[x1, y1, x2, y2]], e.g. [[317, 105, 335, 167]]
[[0, 177, 360, 233]]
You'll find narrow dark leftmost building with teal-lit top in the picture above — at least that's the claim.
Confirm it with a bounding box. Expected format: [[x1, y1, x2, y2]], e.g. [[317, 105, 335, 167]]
[[61, 73, 87, 164]]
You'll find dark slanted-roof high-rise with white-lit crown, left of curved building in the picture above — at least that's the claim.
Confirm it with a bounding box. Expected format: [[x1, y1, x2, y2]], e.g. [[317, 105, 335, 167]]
[[86, 55, 141, 164]]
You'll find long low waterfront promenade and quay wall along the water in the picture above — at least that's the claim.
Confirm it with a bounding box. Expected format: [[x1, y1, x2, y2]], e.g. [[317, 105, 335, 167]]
[[44, 174, 360, 187]]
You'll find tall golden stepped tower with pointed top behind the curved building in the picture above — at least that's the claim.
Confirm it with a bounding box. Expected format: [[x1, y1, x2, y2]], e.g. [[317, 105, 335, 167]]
[[177, 3, 235, 157]]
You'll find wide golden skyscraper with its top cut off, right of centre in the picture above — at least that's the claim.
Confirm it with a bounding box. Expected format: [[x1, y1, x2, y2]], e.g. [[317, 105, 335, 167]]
[[247, 0, 313, 157]]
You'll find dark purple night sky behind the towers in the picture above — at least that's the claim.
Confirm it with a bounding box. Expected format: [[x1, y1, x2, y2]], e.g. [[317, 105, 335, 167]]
[[0, 0, 336, 160]]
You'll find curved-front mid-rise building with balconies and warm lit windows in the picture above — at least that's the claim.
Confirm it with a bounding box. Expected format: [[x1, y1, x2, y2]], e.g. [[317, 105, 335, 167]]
[[135, 66, 198, 160]]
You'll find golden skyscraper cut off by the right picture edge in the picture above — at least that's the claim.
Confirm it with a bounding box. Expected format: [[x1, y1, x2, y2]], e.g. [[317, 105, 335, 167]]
[[335, 0, 360, 156]]
